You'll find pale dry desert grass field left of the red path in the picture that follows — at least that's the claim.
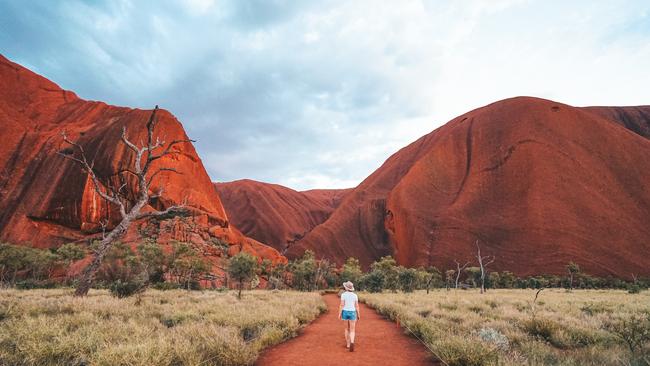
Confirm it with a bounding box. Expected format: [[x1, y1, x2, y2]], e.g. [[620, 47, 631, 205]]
[[0, 289, 326, 366]]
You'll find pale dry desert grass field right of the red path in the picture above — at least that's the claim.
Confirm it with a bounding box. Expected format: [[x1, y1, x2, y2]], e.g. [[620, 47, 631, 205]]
[[361, 289, 650, 366]]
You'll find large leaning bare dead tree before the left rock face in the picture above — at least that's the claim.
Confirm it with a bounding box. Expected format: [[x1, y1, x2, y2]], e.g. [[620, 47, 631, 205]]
[[58, 106, 194, 296]]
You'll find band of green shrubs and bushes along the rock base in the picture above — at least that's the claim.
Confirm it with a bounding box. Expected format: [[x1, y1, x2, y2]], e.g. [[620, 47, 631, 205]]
[[0, 239, 650, 296]]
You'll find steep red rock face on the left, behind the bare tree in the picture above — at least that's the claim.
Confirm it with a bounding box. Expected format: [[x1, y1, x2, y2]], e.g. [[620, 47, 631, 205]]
[[0, 56, 286, 268]]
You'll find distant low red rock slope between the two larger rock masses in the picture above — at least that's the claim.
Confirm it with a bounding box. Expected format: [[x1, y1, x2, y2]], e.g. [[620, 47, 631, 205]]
[[215, 179, 349, 251]]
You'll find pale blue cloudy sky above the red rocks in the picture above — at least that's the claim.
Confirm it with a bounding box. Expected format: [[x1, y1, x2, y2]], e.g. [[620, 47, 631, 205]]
[[0, 0, 650, 190]]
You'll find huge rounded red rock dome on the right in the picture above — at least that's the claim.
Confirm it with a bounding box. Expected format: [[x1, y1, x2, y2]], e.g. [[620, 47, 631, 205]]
[[288, 97, 650, 277]]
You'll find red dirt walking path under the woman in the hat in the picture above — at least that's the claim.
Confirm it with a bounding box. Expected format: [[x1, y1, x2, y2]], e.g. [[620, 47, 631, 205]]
[[255, 294, 438, 366]]
